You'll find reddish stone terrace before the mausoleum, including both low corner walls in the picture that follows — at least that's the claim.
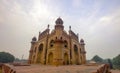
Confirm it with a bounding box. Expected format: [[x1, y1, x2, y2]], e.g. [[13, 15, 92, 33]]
[[2, 64, 111, 73]]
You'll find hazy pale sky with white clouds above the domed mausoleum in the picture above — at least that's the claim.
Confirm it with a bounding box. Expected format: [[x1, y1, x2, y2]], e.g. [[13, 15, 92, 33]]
[[0, 0, 120, 59]]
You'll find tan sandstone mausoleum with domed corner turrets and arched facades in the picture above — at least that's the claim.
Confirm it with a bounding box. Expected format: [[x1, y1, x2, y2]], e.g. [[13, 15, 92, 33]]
[[29, 18, 86, 65]]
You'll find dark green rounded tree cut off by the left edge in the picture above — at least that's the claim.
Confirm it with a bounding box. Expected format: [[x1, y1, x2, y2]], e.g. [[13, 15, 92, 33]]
[[0, 52, 15, 63]]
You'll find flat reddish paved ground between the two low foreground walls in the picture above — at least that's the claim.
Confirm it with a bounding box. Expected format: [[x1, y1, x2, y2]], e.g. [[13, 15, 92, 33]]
[[14, 65, 98, 73]]
